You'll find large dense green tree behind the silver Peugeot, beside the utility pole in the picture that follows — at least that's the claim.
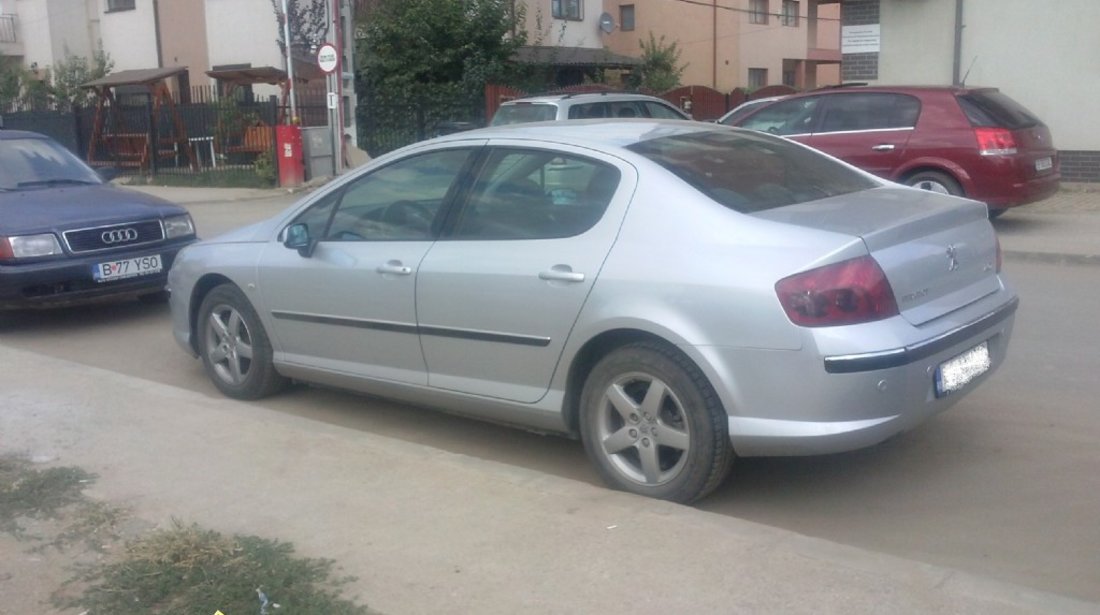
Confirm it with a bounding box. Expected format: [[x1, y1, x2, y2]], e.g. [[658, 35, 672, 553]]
[[356, 0, 526, 155]]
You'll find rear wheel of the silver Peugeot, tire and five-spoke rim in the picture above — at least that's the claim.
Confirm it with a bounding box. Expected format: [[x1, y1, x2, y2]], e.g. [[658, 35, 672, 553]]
[[580, 342, 734, 504]]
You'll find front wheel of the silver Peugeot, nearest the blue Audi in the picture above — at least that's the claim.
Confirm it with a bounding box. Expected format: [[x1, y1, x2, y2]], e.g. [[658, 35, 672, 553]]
[[195, 284, 287, 399]]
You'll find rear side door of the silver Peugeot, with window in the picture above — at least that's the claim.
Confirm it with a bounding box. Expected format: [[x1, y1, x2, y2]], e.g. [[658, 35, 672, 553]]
[[417, 142, 636, 403]]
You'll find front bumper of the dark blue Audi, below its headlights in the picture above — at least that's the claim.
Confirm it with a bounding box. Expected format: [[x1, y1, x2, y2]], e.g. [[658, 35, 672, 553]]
[[0, 241, 190, 309]]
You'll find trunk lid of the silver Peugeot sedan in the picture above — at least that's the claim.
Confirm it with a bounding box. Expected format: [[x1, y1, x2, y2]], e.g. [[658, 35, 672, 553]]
[[755, 187, 1001, 326]]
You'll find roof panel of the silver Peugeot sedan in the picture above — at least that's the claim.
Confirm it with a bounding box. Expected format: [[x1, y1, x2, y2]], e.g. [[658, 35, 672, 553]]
[[430, 119, 717, 149]]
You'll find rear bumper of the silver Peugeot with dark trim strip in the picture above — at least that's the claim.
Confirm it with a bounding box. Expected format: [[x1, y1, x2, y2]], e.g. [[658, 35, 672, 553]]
[[701, 295, 1018, 457]]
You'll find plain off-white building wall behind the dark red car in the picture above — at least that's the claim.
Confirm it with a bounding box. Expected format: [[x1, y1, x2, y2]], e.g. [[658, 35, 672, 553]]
[[878, 0, 1100, 151]]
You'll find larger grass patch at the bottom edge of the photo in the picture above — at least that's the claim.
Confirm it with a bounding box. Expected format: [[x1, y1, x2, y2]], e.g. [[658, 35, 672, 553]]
[[56, 521, 372, 615]]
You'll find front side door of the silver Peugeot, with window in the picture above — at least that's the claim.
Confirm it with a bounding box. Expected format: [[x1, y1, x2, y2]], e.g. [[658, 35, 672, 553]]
[[257, 147, 474, 384]]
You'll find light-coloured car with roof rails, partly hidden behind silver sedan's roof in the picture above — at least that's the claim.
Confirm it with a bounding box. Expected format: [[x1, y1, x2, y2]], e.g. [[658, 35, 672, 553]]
[[491, 92, 691, 127]]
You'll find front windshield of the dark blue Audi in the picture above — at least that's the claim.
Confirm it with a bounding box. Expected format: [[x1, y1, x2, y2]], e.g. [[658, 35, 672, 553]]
[[0, 136, 102, 190]]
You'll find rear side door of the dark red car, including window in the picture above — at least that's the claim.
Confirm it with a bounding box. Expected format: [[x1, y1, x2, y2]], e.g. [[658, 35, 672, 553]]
[[803, 92, 921, 178]]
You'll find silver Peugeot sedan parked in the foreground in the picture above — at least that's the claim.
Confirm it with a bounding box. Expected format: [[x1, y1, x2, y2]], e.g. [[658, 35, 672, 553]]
[[169, 120, 1016, 502]]
